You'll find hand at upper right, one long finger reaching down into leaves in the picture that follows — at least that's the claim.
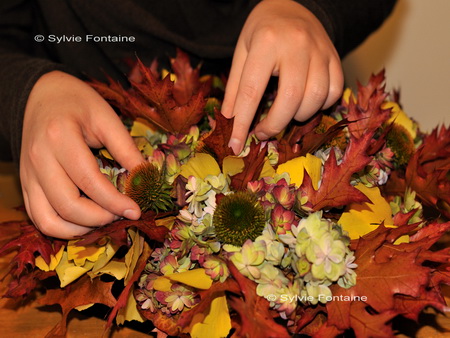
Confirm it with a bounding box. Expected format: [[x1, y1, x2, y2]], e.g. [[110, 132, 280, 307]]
[[222, 0, 343, 154]]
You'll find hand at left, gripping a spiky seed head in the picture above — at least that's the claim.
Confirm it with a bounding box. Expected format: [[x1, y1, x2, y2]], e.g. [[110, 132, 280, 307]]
[[20, 71, 143, 239]]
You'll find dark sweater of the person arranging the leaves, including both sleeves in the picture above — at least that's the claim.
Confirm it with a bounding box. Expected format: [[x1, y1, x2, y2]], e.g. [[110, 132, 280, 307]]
[[0, 0, 395, 161]]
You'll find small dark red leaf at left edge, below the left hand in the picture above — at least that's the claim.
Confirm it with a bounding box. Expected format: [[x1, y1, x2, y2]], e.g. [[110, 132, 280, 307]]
[[0, 221, 63, 277]]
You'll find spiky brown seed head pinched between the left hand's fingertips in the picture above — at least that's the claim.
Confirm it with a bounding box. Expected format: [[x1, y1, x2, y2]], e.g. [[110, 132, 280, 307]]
[[125, 162, 173, 211]]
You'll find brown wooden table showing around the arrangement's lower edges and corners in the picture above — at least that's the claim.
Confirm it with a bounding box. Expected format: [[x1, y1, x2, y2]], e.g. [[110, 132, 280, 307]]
[[0, 163, 450, 338]]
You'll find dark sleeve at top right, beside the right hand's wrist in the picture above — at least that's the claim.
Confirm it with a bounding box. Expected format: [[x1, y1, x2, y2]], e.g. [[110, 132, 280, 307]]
[[295, 0, 396, 57]]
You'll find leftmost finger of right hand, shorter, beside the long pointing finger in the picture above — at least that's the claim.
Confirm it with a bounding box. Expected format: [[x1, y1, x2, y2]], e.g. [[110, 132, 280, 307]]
[[221, 40, 247, 119]]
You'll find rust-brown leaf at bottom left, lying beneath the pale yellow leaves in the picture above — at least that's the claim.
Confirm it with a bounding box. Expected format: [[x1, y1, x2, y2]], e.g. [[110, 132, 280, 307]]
[[39, 275, 116, 337]]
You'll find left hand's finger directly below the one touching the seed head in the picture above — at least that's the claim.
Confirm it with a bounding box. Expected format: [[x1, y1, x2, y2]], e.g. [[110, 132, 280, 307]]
[[37, 160, 117, 227]]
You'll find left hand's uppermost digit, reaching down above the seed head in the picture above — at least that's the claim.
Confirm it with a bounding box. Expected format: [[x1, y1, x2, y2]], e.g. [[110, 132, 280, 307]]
[[89, 106, 145, 171]]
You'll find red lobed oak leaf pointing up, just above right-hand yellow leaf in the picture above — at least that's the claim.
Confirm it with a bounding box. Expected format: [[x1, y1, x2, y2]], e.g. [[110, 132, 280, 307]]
[[300, 133, 373, 211]]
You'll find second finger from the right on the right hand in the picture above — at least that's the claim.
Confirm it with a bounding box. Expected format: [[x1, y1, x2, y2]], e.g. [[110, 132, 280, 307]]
[[294, 58, 330, 121]]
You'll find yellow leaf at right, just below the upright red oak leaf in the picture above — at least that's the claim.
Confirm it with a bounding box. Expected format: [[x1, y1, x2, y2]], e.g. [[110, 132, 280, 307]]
[[338, 183, 409, 244]]
